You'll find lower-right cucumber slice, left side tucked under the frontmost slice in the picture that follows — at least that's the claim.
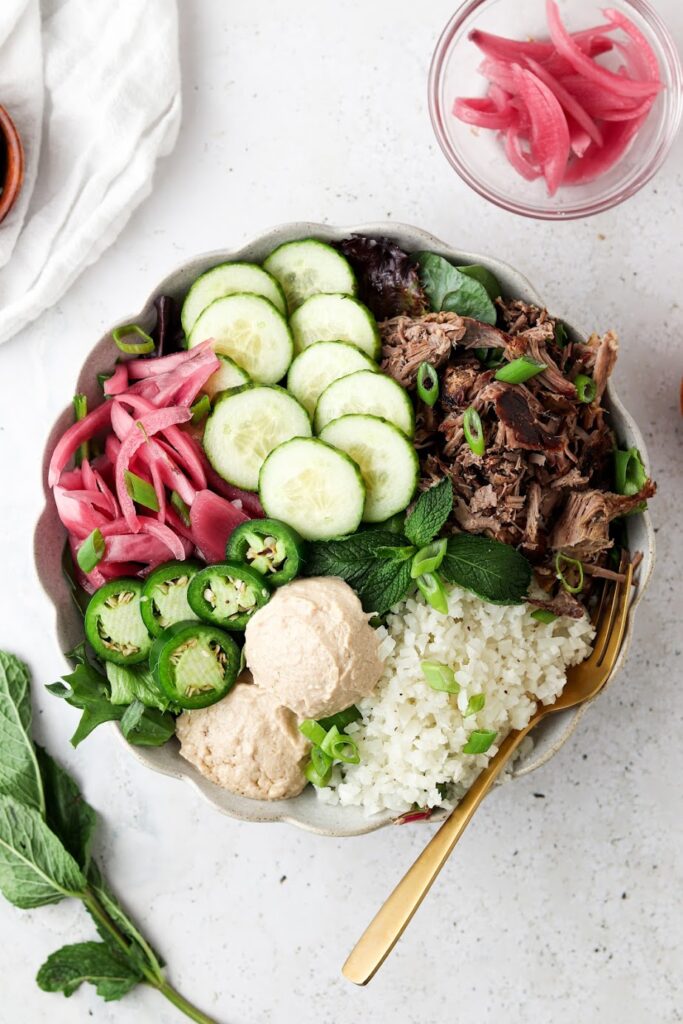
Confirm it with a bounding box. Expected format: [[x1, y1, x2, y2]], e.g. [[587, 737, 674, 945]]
[[321, 415, 420, 522]]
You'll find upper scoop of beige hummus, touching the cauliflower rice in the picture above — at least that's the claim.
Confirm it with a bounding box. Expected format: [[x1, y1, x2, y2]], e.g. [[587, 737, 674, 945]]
[[245, 577, 384, 718]]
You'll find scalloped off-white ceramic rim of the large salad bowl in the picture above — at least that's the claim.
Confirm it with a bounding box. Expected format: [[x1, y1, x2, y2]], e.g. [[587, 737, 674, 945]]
[[35, 222, 654, 836]]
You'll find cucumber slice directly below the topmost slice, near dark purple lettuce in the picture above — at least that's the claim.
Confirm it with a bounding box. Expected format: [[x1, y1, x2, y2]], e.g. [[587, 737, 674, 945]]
[[290, 295, 381, 359]]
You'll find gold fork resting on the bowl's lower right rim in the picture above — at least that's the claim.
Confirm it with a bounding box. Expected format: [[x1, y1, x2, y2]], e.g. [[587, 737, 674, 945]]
[[342, 560, 633, 985]]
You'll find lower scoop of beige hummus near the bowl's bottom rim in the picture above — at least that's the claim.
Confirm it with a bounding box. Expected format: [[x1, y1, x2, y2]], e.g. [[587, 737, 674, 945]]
[[175, 673, 310, 800]]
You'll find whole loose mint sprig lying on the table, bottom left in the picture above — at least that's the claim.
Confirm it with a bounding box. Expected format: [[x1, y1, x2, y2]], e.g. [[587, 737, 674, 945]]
[[0, 651, 216, 1024]]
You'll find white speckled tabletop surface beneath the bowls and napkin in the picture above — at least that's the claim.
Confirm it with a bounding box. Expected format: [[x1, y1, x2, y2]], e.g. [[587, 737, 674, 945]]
[[0, 0, 683, 1024]]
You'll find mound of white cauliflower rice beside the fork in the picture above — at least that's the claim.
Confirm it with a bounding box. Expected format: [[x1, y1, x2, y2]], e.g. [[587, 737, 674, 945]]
[[317, 587, 594, 814]]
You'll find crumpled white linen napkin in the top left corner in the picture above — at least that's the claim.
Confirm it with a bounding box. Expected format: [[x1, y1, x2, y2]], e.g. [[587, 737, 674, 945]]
[[0, 0, 180, 343]]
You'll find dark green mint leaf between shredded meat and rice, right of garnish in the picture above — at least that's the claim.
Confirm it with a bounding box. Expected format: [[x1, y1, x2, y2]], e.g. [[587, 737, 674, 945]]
[[439, 534, 531, 604]]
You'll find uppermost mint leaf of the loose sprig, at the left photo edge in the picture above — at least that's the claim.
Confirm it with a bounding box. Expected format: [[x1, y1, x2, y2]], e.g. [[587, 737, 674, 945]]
[[0, 651, 45, 813]]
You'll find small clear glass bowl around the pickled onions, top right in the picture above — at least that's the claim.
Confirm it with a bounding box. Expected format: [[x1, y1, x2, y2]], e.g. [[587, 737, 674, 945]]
[[429, 0, 683, 220]]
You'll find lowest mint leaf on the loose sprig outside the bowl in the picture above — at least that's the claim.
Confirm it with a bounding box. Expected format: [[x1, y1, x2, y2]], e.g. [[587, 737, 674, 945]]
[[36, 942, 142, 1001]]
